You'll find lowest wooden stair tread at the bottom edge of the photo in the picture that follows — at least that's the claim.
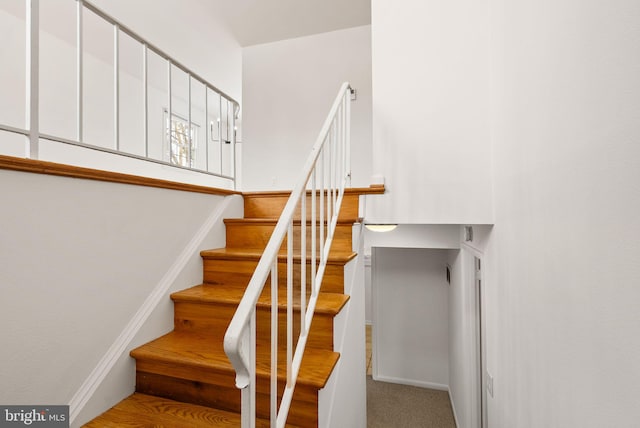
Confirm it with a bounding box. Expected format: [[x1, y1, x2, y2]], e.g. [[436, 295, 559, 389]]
[[84, 393, 269, 428]]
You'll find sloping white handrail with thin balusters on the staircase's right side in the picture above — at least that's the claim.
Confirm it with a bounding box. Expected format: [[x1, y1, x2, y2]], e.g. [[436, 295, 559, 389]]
[[224, 83, 351, 427]]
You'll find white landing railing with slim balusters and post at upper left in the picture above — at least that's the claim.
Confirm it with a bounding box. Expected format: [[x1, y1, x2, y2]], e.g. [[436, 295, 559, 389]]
[[0, 0, 240, 188]]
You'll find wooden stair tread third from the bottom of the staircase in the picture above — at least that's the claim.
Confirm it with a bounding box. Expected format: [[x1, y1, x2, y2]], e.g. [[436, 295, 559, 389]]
[[171, 284, 349, 315]]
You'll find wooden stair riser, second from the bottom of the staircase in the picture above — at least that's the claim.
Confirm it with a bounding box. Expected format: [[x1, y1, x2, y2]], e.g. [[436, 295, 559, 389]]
[[174, 302, 333, 352]]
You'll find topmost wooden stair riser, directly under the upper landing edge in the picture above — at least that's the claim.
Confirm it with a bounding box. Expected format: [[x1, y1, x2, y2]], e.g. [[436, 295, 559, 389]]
[[244, 193, 359, 222]]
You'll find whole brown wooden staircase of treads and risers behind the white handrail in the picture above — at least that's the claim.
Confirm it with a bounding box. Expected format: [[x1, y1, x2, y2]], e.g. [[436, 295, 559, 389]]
[[84, 189, 382, 427]]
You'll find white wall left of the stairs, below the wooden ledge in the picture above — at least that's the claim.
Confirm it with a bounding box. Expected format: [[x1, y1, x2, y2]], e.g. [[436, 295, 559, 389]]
[[0, 170, 241, 410]]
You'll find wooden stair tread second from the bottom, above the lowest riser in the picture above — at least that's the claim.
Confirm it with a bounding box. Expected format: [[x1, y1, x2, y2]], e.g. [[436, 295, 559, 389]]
[[131, 331, 340, 389]]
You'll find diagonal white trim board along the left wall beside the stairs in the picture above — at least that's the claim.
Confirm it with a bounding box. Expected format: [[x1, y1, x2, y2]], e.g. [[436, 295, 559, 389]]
[[69, 195, 241, 423]]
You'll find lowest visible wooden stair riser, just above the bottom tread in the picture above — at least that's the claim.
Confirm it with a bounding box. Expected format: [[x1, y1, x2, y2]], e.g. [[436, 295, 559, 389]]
[[136, 371, 318, 427]]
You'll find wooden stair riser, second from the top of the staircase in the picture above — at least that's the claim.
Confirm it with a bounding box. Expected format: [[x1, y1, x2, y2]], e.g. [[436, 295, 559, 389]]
[[226, 221, 353, 255]]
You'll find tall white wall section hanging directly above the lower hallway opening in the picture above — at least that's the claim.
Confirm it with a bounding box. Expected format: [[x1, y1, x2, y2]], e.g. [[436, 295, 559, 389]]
[[367, 0, 493, 224]]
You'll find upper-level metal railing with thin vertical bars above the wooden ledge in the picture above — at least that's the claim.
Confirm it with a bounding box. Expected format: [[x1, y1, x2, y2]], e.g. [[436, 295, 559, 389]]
[[0, 0, 239, 187]]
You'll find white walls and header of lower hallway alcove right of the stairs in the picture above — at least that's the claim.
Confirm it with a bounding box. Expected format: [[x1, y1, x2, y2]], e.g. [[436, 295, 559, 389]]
[[365, 224, 491, 427]]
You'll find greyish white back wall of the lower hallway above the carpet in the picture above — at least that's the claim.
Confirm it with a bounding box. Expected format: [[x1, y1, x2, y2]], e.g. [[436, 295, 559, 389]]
[[372, 247, 449, 390]]
